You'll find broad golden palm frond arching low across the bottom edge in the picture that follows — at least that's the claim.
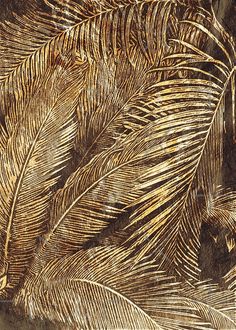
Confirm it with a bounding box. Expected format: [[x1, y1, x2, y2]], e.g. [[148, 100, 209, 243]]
[[14, 247, 216, 330]]
